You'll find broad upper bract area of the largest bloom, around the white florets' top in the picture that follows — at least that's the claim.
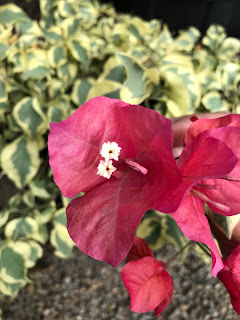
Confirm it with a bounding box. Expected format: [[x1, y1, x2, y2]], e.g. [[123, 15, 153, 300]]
[[48, 97, 181, 201]]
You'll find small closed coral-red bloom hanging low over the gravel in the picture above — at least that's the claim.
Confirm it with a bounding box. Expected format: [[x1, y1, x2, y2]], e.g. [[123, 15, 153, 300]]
[[121, 237, 173, 316]]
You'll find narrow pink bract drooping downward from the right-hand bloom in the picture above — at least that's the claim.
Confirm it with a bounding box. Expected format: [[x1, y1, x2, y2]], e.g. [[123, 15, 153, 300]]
[[171, 193, 223, 277]]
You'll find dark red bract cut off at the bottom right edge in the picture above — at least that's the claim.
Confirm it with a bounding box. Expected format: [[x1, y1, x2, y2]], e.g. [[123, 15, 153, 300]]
[[218, 246, 240, 314]]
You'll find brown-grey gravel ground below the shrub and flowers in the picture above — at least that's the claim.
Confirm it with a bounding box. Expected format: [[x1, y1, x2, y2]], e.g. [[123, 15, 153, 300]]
[[1, 242, 239, 320]]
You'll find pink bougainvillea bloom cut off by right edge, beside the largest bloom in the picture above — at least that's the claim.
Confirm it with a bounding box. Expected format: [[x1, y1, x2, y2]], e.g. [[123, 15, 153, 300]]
[[172, 115, 240, 276]]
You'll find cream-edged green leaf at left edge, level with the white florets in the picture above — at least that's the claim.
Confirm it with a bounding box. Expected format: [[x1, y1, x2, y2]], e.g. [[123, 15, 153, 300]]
[[1, 136, 40, 189]]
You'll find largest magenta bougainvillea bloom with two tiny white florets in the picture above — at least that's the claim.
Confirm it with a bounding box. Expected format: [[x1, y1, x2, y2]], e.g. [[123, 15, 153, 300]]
[[48, 97, 182, 266]]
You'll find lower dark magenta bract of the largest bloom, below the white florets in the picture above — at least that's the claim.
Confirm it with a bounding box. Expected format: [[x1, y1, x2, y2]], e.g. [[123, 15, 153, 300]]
[[67, 179, 156, 267]]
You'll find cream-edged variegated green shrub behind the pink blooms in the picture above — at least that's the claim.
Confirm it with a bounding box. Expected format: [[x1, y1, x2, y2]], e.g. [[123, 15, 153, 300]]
[[0, 0, 240, 306]]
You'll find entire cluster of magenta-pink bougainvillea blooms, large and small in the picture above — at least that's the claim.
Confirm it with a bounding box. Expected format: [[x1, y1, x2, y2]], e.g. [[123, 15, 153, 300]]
[[48, 97, 240, 315]]
